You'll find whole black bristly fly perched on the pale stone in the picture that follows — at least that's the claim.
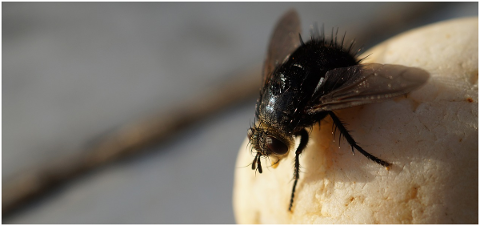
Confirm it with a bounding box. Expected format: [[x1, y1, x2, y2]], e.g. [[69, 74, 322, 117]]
[[247, 10, 429, 211]]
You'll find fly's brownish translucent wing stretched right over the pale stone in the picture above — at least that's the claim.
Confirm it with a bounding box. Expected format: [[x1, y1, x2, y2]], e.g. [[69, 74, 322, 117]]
[[307, 63, 430, 114]]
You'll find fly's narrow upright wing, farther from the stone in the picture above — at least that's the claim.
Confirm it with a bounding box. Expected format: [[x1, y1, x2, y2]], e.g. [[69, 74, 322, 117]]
[[263, 9, 301, 84]]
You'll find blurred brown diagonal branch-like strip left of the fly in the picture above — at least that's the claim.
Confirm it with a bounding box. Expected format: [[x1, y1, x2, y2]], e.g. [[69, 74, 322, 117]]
[[2, 68, 261, 217]]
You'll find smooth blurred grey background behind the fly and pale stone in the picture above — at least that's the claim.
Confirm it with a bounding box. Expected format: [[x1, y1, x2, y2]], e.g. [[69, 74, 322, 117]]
[[2, 3, 478, 223]]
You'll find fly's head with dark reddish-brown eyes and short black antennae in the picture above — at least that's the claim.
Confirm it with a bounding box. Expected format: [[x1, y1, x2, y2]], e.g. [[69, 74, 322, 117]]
[[247, 123, 294, 173]]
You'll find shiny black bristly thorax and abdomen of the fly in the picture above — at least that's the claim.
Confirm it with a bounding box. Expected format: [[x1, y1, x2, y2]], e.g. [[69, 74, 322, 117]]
[[255, 36, 358, 138]]
